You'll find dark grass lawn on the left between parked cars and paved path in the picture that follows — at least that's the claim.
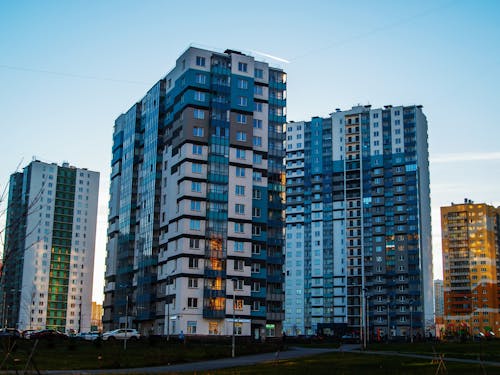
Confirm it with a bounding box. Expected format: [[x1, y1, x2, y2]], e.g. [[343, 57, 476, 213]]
[[0, 339, 277, 370]]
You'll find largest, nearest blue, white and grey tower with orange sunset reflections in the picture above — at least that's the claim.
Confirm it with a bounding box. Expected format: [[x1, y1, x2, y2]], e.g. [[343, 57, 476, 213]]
[[103, 48, 286, 338]]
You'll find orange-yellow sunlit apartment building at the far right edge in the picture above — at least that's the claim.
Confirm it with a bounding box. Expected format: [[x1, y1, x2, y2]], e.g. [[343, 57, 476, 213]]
[[441, 199, 500, 335]]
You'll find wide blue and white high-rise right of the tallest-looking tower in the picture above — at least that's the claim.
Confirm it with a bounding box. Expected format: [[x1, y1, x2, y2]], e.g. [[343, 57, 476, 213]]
[[284, 106, 433, 338]]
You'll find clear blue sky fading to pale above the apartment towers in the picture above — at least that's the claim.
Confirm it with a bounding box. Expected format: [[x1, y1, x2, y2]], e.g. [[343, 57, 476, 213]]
[[0, 0, 500, 301]]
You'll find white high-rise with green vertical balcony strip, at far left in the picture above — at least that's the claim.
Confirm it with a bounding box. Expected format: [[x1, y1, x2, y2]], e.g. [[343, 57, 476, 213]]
[[1, 160, 99, 332]]
